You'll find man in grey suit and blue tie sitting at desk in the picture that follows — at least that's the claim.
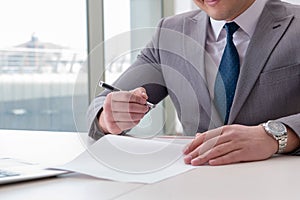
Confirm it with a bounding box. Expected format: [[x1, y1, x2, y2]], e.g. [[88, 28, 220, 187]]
[[88, 0, 300, 165]]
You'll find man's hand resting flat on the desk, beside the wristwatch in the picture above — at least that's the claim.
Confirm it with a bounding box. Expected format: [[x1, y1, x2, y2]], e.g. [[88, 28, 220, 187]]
[[184, 125, 278, 165]]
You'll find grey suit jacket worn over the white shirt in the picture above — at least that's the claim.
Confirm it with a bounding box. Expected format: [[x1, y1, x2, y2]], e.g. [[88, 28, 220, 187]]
[[88, 0, 300, 144]]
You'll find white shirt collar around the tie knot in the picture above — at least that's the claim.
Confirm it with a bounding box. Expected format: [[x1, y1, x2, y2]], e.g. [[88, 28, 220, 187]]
[[210, 0, 268, 41]]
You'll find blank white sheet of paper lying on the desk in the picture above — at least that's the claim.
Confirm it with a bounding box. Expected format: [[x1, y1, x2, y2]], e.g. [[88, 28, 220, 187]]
[[58, 135, 194, 183]]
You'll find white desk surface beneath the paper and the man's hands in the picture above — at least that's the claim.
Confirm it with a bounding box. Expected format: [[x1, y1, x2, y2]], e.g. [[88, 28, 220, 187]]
[[0, 130, 300, 200]]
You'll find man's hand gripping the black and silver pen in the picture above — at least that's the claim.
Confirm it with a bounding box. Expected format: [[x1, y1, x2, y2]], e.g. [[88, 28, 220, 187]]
[[99, 87, 149, 134]]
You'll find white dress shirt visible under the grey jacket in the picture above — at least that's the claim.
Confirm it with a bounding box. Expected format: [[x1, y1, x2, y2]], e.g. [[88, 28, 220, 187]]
[[205, 0, 268, 99]]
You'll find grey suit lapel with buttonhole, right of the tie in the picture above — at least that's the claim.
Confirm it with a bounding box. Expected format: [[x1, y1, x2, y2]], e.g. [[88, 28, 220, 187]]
[[228, 3, 293, 124]]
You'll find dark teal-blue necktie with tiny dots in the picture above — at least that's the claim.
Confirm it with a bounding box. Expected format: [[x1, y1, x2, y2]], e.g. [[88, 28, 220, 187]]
[[214, 22, 240, 124]]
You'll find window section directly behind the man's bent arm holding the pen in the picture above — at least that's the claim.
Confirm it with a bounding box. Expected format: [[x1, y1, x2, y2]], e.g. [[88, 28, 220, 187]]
[[103, 0, 164, 136]]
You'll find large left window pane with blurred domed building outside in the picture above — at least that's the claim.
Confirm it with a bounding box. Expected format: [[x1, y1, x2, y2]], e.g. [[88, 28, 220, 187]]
[[0, 0, 88, 131]]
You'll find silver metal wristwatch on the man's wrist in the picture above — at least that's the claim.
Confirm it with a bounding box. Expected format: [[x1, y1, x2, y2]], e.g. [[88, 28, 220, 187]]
[[262, 120, 287, 153]]
